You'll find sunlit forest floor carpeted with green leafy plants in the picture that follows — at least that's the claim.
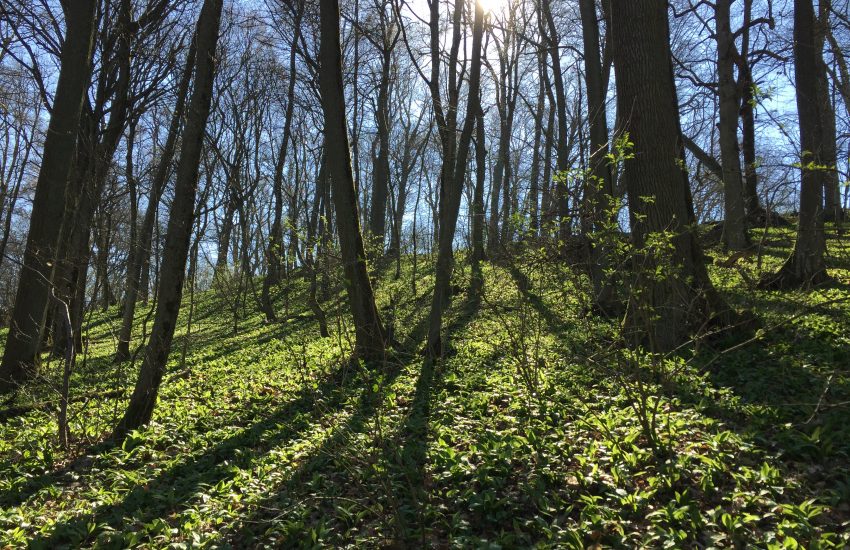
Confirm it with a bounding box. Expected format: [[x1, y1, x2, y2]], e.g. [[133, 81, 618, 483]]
[[0, 230, 850, 548]]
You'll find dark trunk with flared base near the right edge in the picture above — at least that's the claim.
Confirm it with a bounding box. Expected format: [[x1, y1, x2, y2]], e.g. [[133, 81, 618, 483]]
[[762, 0, 828, 288]]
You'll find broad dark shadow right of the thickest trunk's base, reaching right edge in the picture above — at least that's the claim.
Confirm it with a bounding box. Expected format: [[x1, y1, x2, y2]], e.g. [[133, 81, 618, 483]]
[[674, 310, 850, 520]]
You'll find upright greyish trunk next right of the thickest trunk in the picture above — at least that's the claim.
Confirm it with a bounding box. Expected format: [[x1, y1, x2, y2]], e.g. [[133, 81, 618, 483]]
[[715, 0, 749, 250]]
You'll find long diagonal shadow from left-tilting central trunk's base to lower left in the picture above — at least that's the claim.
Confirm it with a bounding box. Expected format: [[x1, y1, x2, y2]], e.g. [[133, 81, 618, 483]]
[[24, 363, 359, 548]]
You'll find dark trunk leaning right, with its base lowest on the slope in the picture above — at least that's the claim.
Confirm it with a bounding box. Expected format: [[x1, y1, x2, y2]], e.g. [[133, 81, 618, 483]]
[[113, 0, 222, 440]]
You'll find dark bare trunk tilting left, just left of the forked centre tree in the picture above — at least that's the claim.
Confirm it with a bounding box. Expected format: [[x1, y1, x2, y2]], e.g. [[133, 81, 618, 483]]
[[319, 0, 386, 359]]
